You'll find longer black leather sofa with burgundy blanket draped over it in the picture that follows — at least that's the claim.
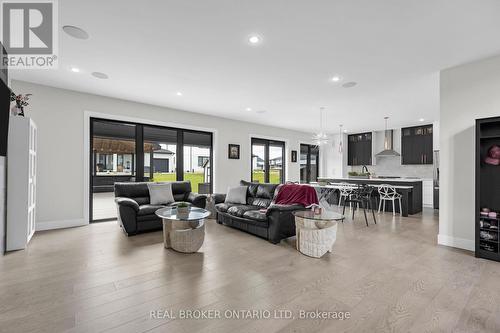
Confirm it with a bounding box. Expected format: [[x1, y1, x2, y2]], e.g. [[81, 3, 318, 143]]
[[214, 180, 305, 244]]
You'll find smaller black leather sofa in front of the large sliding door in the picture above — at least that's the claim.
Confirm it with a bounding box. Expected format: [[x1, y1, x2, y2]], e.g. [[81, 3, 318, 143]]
[[115, 181, 207, 236]]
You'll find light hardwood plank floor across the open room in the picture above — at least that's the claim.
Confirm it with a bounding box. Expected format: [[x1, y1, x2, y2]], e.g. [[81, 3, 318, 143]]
[[0, 210, 500, 332]]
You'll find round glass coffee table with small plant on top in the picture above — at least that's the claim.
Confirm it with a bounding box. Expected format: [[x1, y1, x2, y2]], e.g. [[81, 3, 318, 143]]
[[156, 207, 210, 253]]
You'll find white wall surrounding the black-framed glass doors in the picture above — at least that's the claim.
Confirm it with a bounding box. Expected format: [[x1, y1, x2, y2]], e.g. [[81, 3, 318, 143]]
[[12, 81, 311, 230]]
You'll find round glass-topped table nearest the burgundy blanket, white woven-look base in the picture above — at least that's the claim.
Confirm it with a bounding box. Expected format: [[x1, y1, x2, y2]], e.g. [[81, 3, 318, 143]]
[[292, 210, 344, 258]]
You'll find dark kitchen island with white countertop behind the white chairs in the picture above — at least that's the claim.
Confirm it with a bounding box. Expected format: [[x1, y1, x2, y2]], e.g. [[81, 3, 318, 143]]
[[318, 177, 422, 216]]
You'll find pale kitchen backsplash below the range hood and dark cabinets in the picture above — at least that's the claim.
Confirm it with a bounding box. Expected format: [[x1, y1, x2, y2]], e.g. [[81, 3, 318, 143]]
[[350, 156, 433, 179]]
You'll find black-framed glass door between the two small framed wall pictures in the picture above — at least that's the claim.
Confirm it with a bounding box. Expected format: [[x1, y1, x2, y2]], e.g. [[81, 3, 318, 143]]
[[251, 138, 285, 184]]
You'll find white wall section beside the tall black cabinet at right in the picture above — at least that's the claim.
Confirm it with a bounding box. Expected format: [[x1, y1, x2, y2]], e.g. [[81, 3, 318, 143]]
[[438, 53, 500, 250]]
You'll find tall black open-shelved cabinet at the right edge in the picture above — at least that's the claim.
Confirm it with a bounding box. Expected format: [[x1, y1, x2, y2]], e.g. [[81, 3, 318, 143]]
[[475, 117, 500, 261]]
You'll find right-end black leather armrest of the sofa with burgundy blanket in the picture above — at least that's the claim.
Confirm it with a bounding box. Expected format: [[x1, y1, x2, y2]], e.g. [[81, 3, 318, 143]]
[[266, 205, 306, 244]]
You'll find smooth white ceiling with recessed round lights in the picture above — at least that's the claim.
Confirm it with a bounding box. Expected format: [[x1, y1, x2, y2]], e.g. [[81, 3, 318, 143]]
[[12, 0, 500, 132]]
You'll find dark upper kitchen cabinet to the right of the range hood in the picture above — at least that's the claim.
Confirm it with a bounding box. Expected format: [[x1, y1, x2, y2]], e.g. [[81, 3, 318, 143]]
[[401, 125, 434, 164]]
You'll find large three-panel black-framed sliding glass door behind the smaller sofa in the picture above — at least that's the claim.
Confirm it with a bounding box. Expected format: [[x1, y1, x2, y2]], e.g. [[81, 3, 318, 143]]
[[89, 118, 213, 222]]
